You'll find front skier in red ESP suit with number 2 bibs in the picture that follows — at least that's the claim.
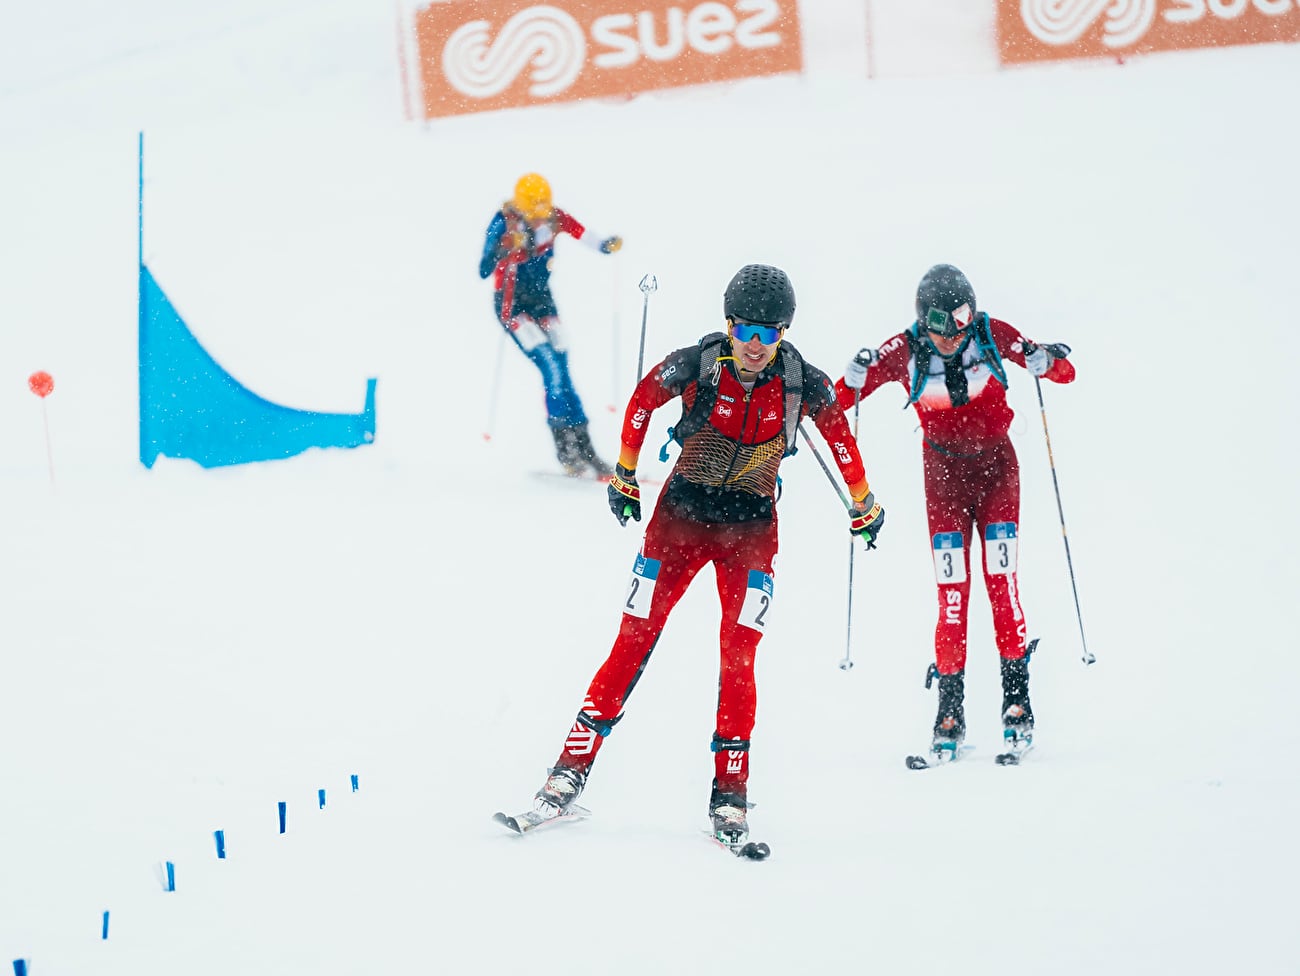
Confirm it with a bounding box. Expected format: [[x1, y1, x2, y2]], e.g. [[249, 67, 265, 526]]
[[525, 265, 884, 847]]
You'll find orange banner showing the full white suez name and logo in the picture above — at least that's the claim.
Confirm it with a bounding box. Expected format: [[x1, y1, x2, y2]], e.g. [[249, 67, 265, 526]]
[[415, 0, 803, 118]]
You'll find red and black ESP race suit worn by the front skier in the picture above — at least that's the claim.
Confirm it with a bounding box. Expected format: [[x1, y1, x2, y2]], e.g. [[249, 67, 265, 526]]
[[559, 333, 870, 797]]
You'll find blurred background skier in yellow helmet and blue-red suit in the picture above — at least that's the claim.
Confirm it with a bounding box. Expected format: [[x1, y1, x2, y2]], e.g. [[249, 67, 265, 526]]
[[478, 173, 623, 477]]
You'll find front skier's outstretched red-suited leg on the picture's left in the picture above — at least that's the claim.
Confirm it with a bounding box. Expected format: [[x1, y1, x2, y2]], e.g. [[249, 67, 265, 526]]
[[558, 507, 709, 775]]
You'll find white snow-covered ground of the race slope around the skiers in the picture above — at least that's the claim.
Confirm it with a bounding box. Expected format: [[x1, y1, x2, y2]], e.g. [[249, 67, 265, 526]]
[[0, 0, 1300, 976]]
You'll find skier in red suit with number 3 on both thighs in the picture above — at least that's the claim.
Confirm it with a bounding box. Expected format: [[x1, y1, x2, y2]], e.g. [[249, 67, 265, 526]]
[[836, 264, 1074, 762]]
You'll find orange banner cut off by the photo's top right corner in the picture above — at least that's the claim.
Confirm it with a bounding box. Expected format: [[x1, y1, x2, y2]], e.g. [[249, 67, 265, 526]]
[[997, 0, 1300, 64]]
